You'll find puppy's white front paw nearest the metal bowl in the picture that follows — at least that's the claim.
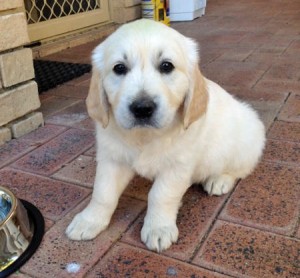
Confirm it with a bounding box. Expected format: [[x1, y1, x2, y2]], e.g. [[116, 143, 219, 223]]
[[66, 211, 108, 240]]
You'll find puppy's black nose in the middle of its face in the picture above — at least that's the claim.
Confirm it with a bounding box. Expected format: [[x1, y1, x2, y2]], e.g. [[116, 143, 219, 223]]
[[129, 98, 156, 120]]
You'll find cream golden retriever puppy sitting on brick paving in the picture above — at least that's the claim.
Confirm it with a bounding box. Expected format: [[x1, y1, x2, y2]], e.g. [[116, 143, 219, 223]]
[[66, 19, 265, 252]]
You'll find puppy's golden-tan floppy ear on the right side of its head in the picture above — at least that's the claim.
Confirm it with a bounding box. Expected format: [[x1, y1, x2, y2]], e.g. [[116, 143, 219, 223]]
[[183, 65, 208, 129]]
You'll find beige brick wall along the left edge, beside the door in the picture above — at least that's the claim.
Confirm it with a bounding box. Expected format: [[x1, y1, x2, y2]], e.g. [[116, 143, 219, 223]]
[[0, 0, 43, 144]]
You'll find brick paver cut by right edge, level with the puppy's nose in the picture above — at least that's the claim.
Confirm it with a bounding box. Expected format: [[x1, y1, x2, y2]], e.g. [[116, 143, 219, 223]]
[[278, 93, 300, 123]]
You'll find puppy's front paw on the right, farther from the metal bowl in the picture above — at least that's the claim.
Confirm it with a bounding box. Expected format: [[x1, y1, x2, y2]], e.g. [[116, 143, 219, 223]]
[[141, 222, 178, 252]]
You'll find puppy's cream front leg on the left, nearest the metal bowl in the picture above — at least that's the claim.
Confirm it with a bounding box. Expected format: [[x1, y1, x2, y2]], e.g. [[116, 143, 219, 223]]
[[66, 161, 134, 240]]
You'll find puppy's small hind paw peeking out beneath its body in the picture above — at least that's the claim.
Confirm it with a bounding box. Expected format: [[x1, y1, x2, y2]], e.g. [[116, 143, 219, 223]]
[[203, 175, 235, 196]]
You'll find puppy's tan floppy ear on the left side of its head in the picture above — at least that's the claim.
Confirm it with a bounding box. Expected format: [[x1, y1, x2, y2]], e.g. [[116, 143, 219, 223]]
[[86, 66, 109, 128]]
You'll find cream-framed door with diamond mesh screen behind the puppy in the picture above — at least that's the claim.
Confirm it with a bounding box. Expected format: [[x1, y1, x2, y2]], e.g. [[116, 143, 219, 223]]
[[24, 0, 109, 42]]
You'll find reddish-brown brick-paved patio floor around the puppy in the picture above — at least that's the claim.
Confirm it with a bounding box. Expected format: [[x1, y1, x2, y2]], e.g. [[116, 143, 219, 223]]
[[0, 0, 300, 278]]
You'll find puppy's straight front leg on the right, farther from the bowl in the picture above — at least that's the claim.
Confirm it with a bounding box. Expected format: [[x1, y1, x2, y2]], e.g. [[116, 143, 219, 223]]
[[141, 173, 190, 252]]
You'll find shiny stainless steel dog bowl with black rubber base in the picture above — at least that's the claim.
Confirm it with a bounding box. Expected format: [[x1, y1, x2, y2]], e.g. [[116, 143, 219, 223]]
[[0, 186, 44, 277]]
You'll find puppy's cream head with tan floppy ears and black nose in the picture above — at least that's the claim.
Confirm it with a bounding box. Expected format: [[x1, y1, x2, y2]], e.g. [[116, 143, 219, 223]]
[[87, 20, 207, 129]]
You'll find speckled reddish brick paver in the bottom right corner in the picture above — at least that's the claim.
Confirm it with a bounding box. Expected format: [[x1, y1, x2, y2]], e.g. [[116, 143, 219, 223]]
[[193, 221, 300, 277]]
